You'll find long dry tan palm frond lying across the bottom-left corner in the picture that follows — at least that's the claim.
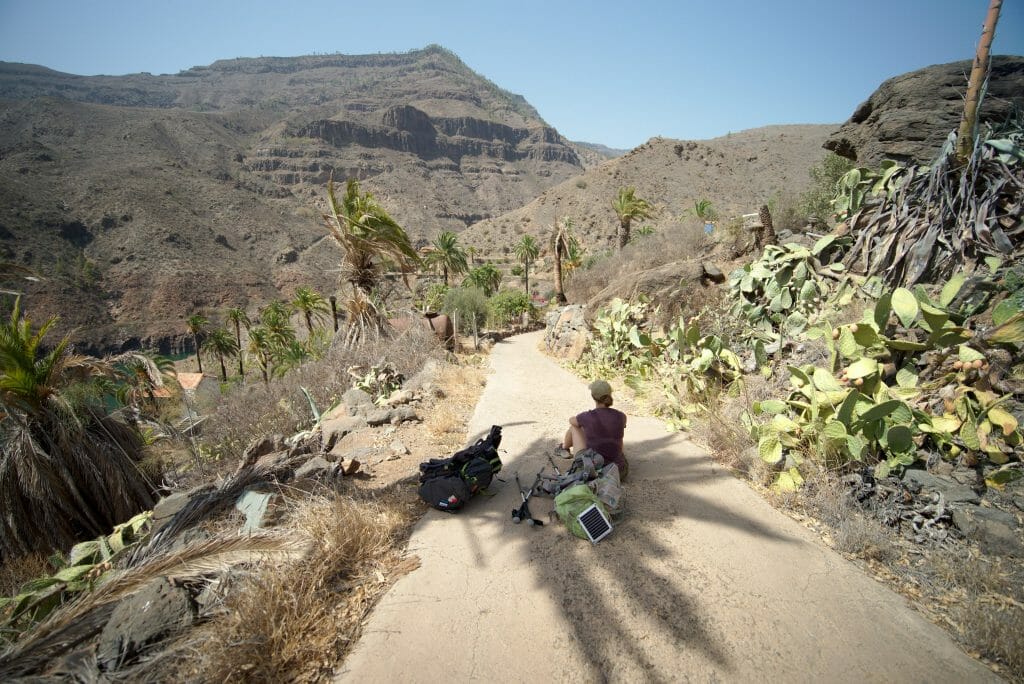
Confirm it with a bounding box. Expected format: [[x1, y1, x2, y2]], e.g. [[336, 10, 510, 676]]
[[0, 533, 311, 681]]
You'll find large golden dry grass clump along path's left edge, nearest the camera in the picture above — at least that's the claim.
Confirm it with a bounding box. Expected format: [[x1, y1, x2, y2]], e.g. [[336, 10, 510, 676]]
[[172, 488, 421, 682]]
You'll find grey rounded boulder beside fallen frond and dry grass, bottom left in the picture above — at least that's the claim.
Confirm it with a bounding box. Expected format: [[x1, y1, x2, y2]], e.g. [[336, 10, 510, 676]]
[[96, 578, 194, 672]]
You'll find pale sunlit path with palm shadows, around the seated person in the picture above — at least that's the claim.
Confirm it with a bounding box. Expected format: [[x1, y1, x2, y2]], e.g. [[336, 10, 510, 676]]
[[339, 333, 997, 683]]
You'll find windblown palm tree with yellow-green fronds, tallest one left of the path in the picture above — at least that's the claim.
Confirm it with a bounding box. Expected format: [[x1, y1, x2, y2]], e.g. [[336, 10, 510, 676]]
[[324, 178, 420, 343]]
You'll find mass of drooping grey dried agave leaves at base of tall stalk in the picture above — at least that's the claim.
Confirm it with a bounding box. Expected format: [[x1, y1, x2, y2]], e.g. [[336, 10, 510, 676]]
[[844, 125, 1024, 287]]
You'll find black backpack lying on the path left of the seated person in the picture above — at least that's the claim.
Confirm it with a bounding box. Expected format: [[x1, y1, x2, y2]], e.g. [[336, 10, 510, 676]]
[[419, 425, 502, 511]]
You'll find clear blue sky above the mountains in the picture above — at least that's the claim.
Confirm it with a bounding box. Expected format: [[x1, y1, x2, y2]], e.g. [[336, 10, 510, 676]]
[[0, 0, 1024, 147]]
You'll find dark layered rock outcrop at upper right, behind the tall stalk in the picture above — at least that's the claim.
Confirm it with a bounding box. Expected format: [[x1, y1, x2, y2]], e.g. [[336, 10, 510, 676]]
[[824, 56, 1024, 167]]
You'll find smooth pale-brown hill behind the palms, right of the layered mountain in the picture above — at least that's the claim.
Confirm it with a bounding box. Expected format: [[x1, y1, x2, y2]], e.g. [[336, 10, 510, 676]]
[[463, 125, 836, 254]]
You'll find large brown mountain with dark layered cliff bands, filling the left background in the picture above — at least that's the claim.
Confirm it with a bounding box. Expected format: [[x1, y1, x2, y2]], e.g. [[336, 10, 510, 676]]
[[0, 47, 583, 351]]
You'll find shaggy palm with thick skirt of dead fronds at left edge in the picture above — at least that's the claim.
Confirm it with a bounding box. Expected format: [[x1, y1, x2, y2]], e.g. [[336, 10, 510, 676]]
[[0, 300, 154, 558]]
